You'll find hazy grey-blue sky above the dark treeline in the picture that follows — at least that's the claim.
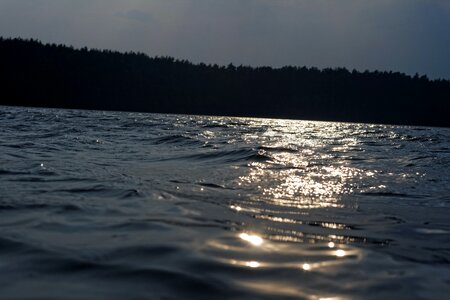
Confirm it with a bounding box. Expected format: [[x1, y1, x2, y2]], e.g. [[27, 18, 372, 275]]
[[0, 0, 450, 79]]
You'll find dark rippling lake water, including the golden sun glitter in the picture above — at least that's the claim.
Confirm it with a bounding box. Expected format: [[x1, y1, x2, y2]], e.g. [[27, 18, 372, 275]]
[[0, 107, 450, 299]]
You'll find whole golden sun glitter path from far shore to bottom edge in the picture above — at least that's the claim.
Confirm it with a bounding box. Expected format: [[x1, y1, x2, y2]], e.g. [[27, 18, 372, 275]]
[[193, 120, 414, 299]]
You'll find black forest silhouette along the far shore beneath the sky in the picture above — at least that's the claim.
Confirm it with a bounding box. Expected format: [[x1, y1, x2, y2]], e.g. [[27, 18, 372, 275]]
[[0, 38, 450, 127]]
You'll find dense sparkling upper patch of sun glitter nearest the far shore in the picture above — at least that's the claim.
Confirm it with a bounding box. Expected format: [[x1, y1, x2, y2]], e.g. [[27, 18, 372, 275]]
[[239, 120, 370, 209]]
